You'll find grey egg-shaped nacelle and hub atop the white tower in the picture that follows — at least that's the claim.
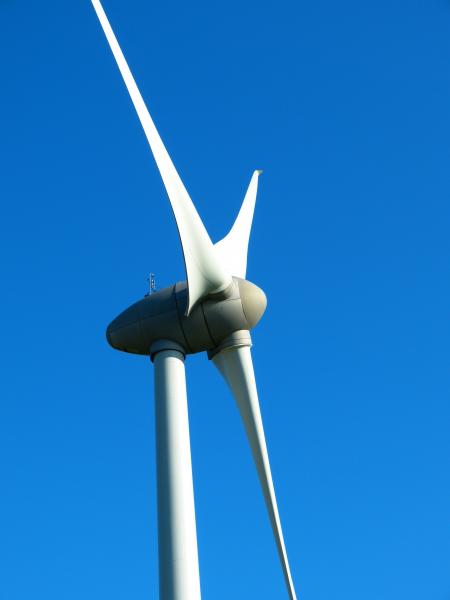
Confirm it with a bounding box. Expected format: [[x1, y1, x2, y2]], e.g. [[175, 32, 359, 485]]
[[106, 277, 267, 355]]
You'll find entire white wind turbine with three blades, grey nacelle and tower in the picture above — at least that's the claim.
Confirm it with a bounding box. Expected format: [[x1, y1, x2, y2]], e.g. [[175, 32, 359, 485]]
[[91, 0, 296, 600]]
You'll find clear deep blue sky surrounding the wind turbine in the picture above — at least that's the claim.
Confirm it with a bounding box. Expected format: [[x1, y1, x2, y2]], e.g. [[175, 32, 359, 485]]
[[0, 0, 450, 600]]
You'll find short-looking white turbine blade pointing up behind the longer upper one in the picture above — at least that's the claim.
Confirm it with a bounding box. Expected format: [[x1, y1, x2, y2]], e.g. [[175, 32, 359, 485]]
[[214, 171, 262, 279]]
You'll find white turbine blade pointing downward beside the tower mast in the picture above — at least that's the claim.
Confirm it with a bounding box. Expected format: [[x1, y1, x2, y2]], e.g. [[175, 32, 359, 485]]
[[212, 346, 297, 600]]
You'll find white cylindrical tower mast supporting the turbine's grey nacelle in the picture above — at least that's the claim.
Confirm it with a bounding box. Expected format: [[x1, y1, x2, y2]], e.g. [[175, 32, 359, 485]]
[[153, 345, 200, 600]]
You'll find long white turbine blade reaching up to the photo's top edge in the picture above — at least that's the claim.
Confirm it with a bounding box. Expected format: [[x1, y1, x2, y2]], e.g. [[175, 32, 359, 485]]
[[92, 0, 231, 314]]
